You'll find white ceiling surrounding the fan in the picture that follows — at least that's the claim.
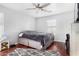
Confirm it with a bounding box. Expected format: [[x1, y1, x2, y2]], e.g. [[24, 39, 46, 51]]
[[1, 3, 74, 17]]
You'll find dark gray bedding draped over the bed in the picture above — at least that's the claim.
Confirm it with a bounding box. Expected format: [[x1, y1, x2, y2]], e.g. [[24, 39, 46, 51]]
[[19, 31, 54, 49]]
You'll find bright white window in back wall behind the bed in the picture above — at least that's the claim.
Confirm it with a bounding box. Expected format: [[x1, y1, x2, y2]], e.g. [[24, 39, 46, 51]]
[[46, 19, 56, 34]]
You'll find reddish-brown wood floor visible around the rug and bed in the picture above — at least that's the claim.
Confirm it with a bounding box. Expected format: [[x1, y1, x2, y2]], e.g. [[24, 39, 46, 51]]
[[0, 42, 68, 56]]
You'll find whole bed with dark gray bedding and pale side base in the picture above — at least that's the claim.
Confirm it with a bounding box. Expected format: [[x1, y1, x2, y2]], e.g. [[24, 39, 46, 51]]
[[18, 31, 54, 50]]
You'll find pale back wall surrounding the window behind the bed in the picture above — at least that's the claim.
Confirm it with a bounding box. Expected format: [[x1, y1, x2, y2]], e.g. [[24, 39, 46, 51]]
[[37, 11, 74, 42]]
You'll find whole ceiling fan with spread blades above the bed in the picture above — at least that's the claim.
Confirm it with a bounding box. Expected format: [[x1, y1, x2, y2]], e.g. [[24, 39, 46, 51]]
[[26, 3, 51, 12]]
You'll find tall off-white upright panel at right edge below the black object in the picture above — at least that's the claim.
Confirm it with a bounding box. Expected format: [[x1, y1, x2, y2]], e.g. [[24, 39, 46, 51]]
[[70, 23, 79, 56]]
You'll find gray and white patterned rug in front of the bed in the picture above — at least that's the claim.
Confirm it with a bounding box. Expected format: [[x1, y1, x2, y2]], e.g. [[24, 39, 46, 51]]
[[8, 48, 60, 56]]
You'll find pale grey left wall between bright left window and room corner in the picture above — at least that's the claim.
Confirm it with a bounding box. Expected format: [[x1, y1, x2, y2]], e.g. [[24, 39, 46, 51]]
[[0, 5, 35, 44]]
